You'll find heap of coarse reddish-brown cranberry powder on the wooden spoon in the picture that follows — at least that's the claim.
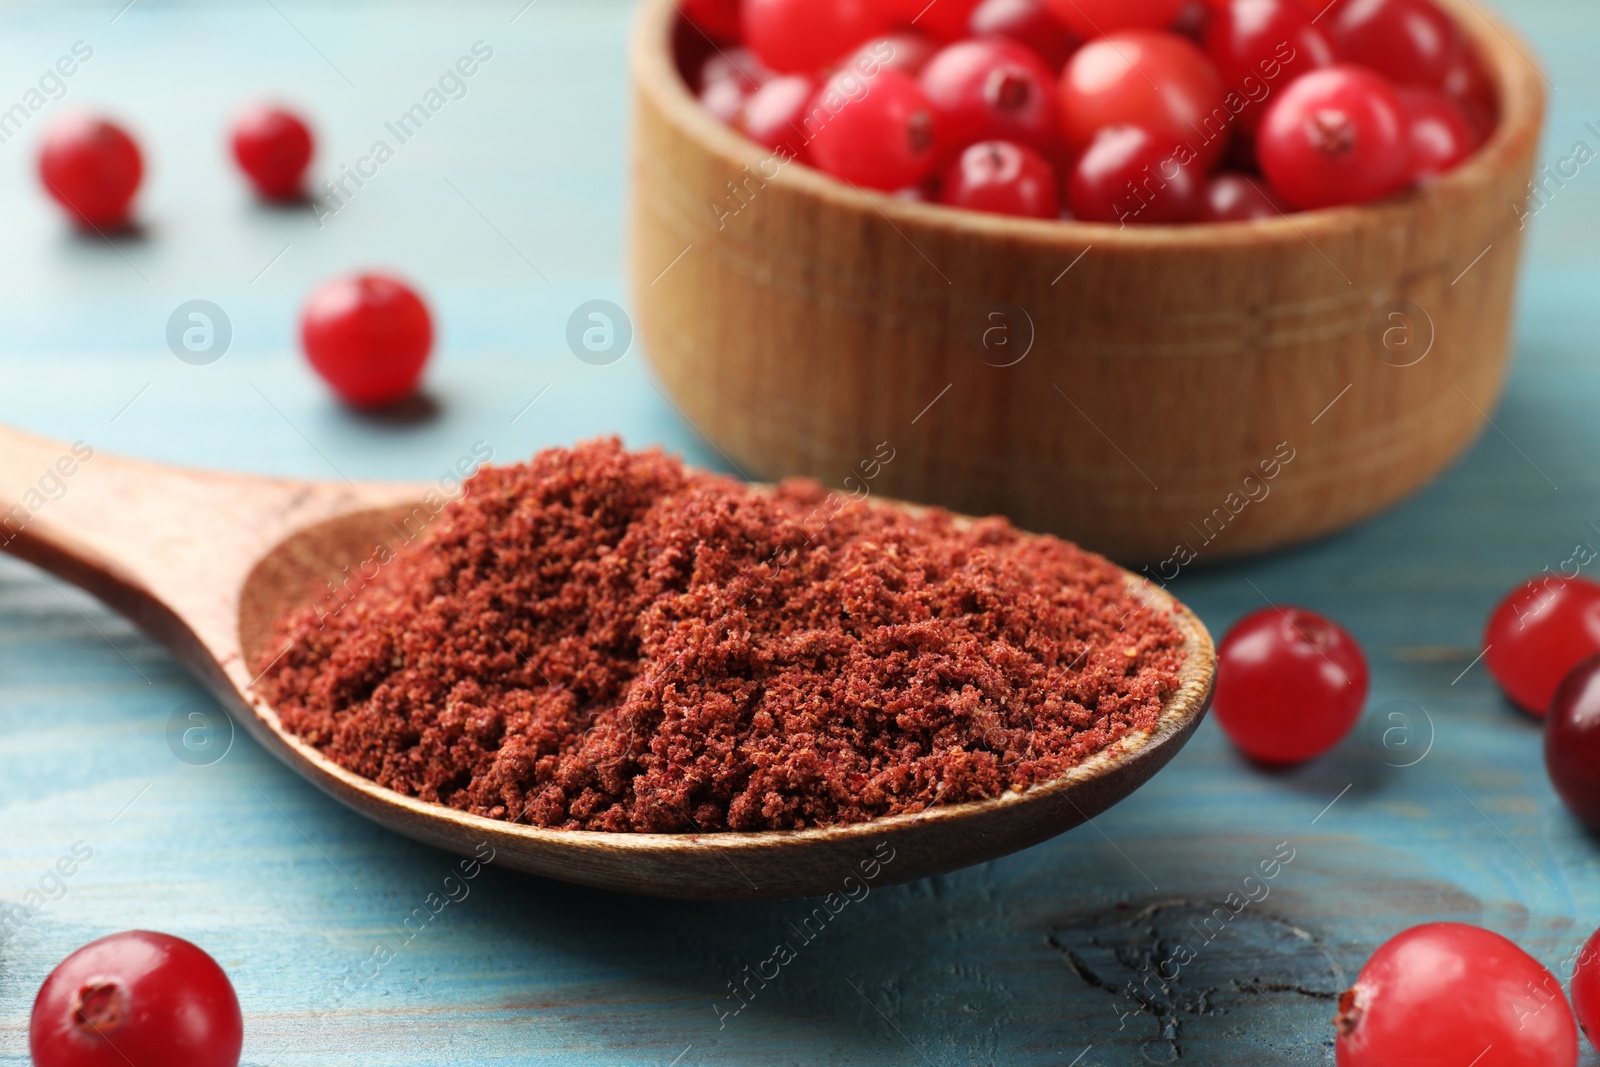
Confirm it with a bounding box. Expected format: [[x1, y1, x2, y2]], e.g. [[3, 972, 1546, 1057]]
[[258, 440, 1182, 832]]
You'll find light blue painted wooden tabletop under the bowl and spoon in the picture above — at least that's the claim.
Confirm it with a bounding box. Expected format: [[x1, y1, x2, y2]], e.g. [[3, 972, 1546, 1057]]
[[0, 0, 1600, 1067]]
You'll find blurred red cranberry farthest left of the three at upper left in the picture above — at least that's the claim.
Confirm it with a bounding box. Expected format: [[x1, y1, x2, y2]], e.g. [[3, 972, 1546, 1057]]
[[38, 115, 144, 229]]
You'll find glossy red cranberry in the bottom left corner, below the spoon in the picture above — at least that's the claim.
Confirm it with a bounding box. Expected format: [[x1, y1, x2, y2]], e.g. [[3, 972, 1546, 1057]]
[[27, 929, 245, 1067]]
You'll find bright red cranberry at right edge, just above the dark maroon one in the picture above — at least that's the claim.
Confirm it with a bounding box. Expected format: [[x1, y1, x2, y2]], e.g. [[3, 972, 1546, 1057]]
[[1483, 574, 1600, 715]]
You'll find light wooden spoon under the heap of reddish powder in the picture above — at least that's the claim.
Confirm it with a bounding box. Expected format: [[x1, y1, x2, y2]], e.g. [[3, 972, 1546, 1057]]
[[0, 429, 1216, 899]]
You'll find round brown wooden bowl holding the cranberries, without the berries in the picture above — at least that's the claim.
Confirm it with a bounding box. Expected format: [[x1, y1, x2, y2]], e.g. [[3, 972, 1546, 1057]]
[[632, 0, 1544, 563]]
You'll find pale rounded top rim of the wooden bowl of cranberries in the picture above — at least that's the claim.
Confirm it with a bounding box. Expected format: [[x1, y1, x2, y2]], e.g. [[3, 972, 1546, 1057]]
[[629, 0, 1547, 250]]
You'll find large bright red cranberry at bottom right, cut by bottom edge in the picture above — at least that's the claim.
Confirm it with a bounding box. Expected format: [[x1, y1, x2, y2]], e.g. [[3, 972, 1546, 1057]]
[[1336, 923, 1578, 1067]]
